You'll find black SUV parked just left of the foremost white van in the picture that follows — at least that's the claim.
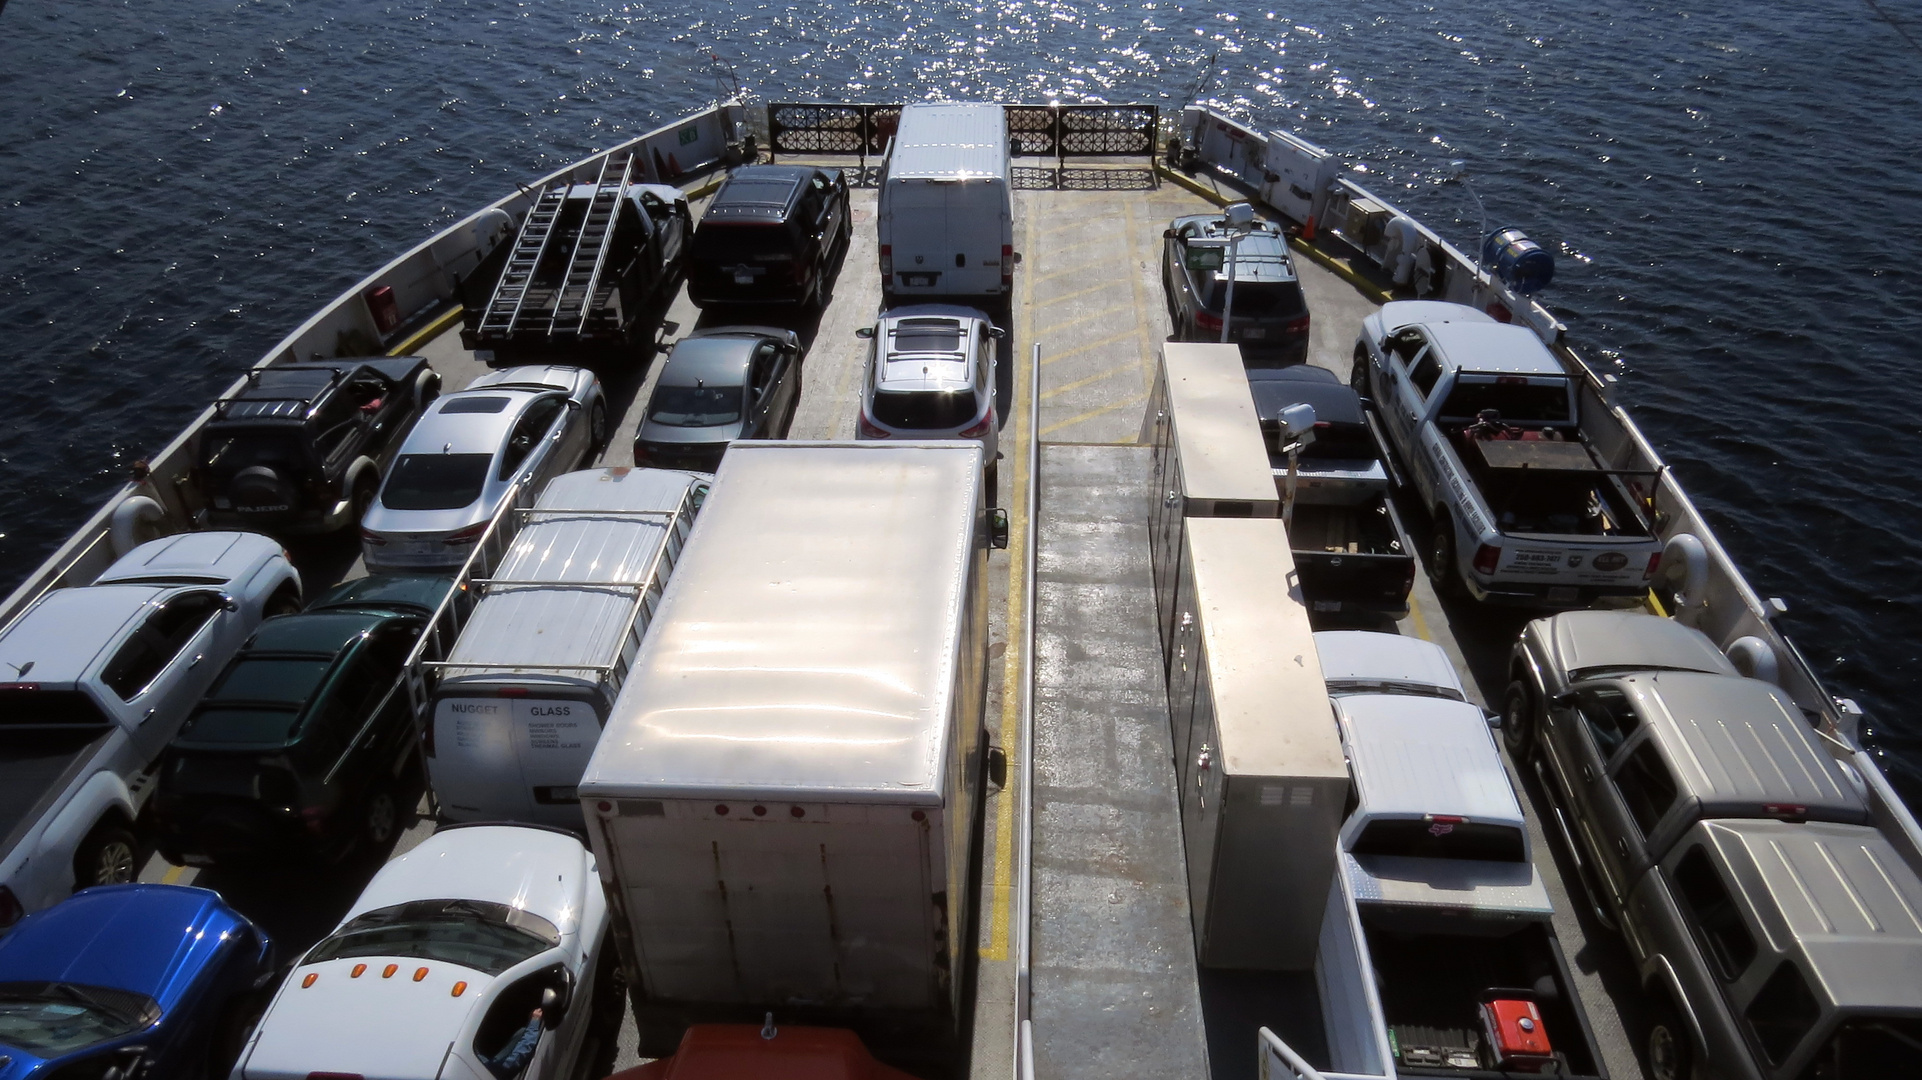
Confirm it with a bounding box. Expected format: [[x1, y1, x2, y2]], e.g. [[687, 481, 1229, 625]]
[[688, 165, 853, 307]]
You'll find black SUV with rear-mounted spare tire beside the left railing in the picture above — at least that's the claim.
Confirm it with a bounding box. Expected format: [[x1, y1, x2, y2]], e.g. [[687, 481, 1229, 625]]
[[192, 356, 440, 534]]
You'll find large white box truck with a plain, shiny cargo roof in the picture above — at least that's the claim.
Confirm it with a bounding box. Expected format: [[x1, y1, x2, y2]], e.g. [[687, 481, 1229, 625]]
[[580, 442, 992, 1055]]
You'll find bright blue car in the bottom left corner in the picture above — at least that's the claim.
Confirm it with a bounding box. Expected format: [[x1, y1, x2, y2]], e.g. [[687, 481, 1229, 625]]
[[0, 884, 275, 1080]]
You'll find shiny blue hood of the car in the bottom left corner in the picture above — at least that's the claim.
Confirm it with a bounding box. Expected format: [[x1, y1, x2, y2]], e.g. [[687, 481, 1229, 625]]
[[0, 884, 248, 1013]]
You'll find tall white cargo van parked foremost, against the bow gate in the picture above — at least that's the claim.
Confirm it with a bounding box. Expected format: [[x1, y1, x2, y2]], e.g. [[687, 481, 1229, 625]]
[[876, 104, 1021, 304]]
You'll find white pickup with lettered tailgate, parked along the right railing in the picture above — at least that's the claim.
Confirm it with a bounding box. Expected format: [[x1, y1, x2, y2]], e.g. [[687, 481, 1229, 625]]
[[1351, 300, 1663, 607]]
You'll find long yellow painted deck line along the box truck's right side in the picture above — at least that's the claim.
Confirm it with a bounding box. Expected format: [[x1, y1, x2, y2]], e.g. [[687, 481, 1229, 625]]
[[980, 197, 1040, 961]]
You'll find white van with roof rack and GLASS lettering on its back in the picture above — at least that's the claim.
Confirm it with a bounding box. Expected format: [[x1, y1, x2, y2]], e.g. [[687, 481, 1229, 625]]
[[423, 469, 709, 830]]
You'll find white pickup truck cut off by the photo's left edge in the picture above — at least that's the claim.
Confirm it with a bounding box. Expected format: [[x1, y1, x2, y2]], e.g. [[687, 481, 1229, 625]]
[[0, 532, 300, 932]]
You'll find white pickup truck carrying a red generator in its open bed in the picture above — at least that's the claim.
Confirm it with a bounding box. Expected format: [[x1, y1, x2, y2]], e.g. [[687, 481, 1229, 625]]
[[1315, 630, 1605, 1080]]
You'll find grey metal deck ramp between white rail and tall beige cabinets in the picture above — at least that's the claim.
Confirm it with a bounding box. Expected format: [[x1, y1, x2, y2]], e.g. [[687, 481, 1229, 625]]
[[1034, 444, 1199, 1080]]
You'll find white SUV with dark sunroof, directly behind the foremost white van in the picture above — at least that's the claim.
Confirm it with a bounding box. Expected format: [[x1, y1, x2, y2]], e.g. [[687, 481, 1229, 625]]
[[855, 304, 1007, 503]]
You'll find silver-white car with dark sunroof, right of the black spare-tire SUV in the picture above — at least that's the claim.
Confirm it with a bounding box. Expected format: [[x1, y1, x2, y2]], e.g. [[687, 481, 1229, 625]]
[[361, 365, 607, 573]]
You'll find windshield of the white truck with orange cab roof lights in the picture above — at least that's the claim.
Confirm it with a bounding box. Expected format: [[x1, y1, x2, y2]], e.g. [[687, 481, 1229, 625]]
[[302, 899, 561, 974]]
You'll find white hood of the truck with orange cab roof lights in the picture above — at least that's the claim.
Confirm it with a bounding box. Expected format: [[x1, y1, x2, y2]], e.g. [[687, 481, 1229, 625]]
[[342, 824, 600, 934]]
